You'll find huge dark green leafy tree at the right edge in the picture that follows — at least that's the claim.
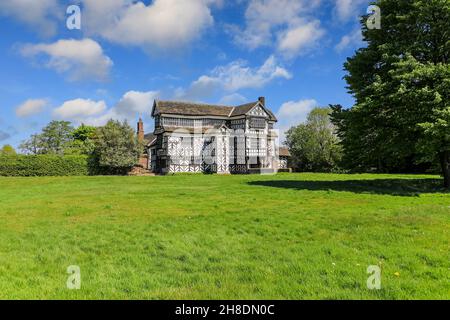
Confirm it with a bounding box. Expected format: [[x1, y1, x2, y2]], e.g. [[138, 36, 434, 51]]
[[332, 0, 450, 188]]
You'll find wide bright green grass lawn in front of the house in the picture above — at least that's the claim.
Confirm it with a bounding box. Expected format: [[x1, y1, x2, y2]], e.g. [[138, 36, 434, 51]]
[[0, 174, 450, 299]]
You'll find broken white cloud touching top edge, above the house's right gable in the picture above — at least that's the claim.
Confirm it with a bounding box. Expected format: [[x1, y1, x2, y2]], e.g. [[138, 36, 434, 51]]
[[228, 0, 324, 56]]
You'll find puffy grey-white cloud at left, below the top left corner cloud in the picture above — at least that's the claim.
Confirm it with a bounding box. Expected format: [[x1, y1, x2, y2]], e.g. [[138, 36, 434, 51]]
[[21, 39, 113, 81]]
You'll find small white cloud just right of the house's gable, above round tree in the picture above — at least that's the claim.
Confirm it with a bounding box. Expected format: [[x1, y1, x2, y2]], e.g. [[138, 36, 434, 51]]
[[276, 99, 318, 142]]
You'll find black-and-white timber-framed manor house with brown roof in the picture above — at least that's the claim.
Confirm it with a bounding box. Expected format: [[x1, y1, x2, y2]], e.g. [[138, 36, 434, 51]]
[[144, 97, 288, 174]]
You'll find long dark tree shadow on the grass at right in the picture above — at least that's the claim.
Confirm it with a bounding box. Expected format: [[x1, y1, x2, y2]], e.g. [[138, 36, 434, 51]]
[[248, 179, 448, 197]]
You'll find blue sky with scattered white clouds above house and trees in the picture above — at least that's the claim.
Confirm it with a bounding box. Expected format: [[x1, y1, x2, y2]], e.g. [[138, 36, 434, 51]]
[[0, 0, 370, 147]]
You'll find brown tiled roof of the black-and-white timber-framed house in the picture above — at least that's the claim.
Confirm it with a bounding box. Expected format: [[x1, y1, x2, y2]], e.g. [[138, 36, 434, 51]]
[[152, 100, 277, 121]]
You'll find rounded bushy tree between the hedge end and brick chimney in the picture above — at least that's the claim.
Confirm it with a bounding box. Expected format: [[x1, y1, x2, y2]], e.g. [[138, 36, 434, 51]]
[[94, 120, 142, 173]]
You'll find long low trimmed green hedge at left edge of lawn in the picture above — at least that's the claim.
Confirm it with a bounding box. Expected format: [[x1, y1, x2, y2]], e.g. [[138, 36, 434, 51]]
[[0, 155, 95, 177]]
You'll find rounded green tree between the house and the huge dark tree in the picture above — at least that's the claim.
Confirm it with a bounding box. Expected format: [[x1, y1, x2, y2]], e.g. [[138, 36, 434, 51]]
[[286, 108, 342, 172]]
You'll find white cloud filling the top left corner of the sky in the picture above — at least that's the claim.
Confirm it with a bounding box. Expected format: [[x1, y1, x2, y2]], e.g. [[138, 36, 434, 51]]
[[0, 0, 60, 36]]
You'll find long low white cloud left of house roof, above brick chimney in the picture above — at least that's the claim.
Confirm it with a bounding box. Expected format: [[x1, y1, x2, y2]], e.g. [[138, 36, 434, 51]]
[[53, 91, 159, 126]]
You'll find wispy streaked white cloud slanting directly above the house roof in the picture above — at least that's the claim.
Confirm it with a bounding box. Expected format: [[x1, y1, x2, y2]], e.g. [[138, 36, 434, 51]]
[[176, 56, 292, 99]]
